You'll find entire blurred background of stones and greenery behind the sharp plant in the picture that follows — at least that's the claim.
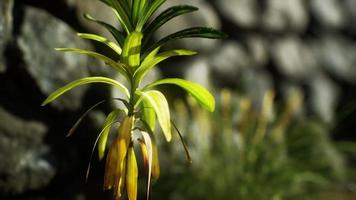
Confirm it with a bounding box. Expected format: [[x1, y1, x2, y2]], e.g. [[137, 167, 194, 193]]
[[0, 0, 356, 200]]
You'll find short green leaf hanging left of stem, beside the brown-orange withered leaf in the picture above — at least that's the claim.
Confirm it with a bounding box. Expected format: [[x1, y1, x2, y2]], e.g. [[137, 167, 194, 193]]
[[98, 109, 123, 160]]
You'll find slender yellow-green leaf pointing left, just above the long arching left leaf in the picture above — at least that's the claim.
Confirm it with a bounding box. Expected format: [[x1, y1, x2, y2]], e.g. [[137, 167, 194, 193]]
[[55, 48, 129, 79]]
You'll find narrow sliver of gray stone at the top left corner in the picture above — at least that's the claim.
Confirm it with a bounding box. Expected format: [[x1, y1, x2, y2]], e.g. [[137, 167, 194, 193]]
[[0, 0, 14, 73]]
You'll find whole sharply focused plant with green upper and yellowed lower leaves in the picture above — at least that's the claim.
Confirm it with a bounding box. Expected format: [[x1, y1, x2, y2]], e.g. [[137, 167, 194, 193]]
[[43, 0, 225, 200]]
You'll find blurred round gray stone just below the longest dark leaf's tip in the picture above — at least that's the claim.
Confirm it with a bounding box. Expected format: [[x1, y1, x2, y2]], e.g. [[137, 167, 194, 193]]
[[211, 41, 252, 82]]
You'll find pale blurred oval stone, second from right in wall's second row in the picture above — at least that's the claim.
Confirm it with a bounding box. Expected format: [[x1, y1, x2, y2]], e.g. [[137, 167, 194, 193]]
[[271, 37, 319, 80]]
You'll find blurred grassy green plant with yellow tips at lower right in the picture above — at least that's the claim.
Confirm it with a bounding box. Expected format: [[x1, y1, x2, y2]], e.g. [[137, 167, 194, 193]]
[[155, 90, 352, 200]]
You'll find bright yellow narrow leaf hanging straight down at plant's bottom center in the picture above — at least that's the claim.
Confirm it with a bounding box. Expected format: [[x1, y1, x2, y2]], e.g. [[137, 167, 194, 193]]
[[126, 147, 138, 200]]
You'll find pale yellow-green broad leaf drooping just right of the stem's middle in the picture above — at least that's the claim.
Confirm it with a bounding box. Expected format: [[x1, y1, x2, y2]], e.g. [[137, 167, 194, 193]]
[[141, 90, 172, 142]]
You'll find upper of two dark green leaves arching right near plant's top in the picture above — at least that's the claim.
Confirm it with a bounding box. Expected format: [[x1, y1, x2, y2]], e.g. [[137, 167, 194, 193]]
[[143, 5, 198, 46]]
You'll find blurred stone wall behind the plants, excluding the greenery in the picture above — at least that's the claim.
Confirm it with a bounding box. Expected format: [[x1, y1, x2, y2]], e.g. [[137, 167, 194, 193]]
[[0, 0, 356, 199]]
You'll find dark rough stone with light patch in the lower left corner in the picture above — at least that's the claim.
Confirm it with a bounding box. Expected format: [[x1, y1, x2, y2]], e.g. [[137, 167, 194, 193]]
[[0, 107, 56, 196]]
